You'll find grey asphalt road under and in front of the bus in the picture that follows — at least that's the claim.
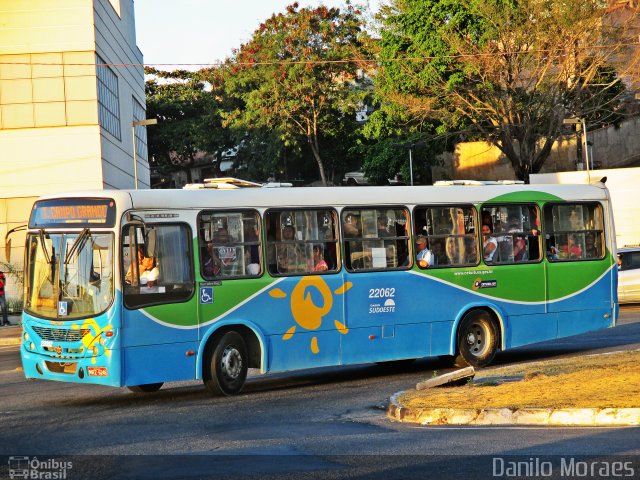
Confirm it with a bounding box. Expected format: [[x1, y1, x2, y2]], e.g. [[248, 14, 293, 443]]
[[0, 307, 640, 479]]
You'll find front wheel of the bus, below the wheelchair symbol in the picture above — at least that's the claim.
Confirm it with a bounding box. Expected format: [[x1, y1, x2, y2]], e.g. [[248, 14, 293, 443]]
[[203, 331, 249, 396]]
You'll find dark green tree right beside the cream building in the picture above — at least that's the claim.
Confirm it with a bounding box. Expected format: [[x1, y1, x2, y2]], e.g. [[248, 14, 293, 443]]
[[145, 68, 233, 182]]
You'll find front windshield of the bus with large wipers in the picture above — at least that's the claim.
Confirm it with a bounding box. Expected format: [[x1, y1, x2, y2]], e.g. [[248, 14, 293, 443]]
[[25, 232, 113, 320]]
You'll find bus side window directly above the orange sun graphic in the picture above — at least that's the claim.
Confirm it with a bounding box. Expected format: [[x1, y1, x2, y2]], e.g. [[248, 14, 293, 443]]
[[265, 209, 339, 276]]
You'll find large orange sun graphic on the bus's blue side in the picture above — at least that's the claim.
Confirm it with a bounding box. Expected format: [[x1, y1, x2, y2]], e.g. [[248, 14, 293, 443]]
[[269, 276, 353, 354]]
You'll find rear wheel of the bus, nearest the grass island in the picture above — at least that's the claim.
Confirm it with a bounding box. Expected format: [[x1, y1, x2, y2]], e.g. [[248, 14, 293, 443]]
[[455, 310, 498, 368]]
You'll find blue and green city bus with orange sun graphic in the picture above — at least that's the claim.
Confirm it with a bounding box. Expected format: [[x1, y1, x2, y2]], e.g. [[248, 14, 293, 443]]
[[21, 182, 618, 395]]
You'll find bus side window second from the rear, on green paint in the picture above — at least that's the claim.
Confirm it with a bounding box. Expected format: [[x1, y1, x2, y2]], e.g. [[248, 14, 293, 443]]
[[481, 204, 540, 264]]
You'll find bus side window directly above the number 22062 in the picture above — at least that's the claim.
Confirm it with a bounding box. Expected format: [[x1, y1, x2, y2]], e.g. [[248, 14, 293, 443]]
[[342, 207, 410, 271]]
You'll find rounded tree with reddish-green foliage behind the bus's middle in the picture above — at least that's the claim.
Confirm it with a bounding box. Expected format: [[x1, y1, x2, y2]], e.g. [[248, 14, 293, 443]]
[[225, 3, 365, 185]]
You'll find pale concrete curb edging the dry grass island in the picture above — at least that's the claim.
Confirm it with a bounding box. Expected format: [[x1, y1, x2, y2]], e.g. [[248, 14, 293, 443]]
[[387, 391, 640, 427]]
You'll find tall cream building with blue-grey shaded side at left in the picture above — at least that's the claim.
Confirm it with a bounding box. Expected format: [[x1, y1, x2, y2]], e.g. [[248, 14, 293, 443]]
[[0, 0, 150, 306]]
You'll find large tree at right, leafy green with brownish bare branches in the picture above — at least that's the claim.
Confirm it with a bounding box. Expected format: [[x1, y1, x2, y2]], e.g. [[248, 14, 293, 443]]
[[377, 0, 631, 181]]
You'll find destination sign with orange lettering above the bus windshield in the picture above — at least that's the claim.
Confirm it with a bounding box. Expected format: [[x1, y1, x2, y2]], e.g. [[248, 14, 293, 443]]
[[29, 198, 116, 228]]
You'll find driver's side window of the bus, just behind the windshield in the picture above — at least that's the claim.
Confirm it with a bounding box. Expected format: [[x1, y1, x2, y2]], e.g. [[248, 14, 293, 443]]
[[122, 224, 194, 308]]
